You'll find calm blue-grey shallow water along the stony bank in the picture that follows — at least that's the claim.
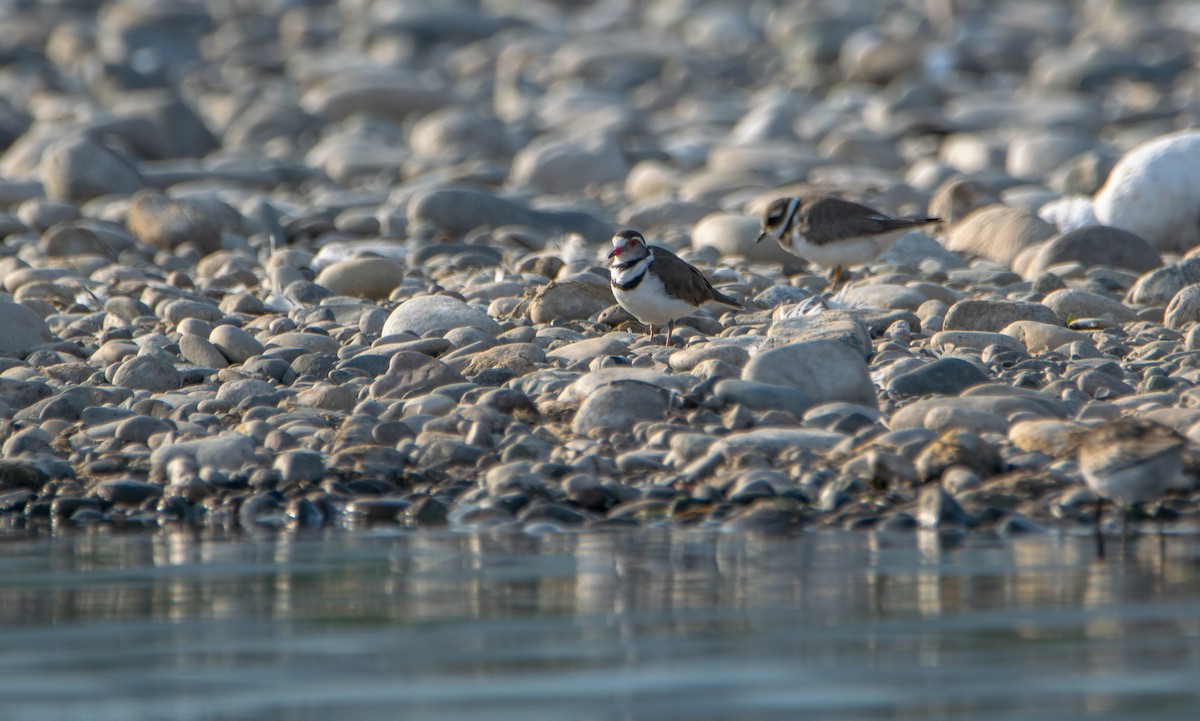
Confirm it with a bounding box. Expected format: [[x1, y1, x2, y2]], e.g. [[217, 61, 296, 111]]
[[0, 530, 1200, 721]]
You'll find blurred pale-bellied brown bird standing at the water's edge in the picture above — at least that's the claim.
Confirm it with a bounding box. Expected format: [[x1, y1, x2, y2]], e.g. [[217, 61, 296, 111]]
[[1076, 416, 1188, 544]]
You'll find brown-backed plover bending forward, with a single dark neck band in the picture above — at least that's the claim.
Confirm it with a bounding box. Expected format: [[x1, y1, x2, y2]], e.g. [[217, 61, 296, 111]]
[[755, 196, 941, 289]]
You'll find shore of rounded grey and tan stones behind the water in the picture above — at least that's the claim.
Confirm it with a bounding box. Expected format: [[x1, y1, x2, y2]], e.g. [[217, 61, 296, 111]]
[[0, 0, 1200, 534]]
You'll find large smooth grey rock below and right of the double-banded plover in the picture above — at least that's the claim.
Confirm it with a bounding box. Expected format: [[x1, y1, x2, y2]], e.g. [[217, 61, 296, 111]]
[[742, 340, 877, 408]]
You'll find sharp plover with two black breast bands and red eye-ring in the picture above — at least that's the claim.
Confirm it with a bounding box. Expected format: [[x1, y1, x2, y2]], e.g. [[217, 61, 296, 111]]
[[608, 230, 742, 346]]
